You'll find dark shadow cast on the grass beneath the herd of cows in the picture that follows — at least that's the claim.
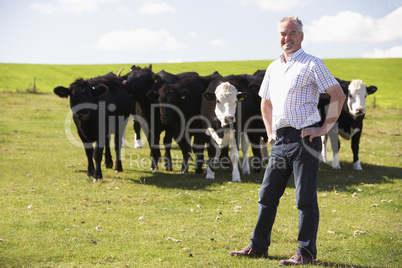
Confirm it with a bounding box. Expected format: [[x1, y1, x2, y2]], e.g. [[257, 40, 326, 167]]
[[121, 158, 402, 191]]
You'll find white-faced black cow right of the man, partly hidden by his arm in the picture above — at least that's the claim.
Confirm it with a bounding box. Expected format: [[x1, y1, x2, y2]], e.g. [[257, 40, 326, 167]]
[[318, 78, 377, 171]]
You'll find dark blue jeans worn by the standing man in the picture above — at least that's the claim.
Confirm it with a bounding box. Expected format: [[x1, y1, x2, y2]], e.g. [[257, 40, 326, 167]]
[[250, 127, 322, 257]]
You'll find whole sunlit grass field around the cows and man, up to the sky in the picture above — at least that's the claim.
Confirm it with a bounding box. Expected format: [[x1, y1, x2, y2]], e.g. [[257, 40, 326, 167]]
[[0, 59, 402, 267]]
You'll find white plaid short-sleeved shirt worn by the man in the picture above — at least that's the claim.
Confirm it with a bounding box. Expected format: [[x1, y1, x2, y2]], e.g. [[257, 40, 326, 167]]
[[259, 48, 338, 133]]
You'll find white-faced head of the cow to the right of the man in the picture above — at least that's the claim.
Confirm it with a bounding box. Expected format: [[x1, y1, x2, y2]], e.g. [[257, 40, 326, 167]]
[[347, 80, 377, 117]]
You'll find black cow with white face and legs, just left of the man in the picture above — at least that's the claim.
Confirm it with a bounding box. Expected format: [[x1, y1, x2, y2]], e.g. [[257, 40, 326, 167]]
[[201, 75, 266, 181]]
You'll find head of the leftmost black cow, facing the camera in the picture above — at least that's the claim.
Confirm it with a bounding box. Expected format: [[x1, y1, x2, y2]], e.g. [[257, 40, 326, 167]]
[[53, 78, 108, 122]]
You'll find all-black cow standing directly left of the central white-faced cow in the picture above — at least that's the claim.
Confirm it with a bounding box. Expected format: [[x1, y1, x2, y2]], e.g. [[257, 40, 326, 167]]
[[155, 72, 210, 173]]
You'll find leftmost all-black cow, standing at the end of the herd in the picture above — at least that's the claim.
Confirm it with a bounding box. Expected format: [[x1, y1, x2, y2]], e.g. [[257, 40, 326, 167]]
[[53, 73, 131, 182]]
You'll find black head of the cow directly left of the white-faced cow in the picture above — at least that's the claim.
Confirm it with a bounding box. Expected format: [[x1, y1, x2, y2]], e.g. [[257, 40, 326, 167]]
[[158, 83, 189, 124]]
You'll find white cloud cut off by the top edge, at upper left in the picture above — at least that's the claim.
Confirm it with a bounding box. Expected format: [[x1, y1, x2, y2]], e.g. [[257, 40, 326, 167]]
[[30, 0, 115, 15]]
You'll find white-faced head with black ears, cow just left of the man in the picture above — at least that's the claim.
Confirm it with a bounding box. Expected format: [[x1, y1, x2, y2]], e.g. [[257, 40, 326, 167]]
[[203, 82, 248, 127]]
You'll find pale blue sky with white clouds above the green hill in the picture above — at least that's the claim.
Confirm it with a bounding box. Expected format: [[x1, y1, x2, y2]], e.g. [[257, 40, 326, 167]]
[[0, 0, 402, 64]]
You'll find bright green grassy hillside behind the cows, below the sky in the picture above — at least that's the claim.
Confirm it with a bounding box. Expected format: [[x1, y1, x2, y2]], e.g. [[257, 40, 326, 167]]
[[0, 58, 402, 108]]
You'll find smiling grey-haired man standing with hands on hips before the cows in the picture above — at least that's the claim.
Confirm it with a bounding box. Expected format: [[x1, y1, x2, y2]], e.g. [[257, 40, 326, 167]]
[[229, 17, 345, 266]]
